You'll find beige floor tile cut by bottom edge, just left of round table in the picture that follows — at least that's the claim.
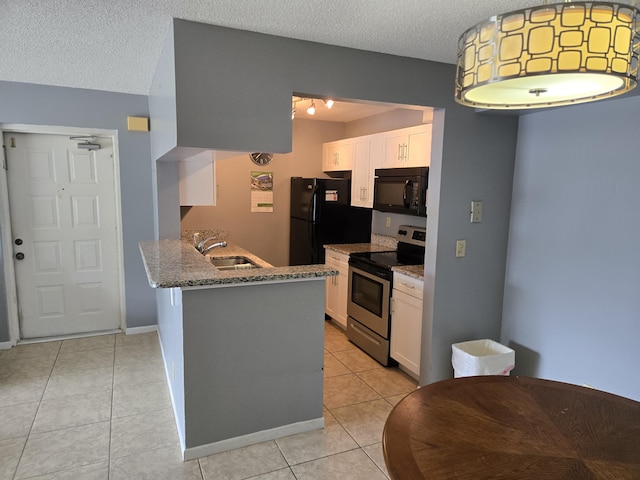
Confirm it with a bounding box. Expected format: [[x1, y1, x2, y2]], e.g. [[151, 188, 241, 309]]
[[291, 449, 386, 480]]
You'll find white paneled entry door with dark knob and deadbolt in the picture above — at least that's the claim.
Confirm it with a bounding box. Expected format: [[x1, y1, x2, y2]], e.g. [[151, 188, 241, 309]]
[[5, 133, 121, 339]]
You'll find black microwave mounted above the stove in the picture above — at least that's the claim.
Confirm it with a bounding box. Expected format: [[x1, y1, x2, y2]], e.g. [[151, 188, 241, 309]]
[[373, 167, 429, 217]]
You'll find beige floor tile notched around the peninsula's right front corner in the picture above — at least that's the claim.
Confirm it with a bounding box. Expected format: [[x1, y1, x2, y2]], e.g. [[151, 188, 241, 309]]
[[276, 408, 358, 465]]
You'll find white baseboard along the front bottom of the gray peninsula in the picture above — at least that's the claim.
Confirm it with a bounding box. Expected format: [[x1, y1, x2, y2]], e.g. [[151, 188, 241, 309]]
[[182, 417, 324, 462]]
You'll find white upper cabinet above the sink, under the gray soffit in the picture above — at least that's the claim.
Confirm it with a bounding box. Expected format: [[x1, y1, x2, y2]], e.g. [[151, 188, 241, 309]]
[[178, 151, 215, 206]]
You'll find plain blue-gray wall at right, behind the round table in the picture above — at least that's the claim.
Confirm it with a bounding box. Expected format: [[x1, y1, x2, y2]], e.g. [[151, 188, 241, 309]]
[[502, 97, 640, 400]]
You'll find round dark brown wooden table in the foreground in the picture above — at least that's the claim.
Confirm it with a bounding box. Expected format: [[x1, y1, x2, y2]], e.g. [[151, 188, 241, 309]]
[[383, 376, 640, 480]]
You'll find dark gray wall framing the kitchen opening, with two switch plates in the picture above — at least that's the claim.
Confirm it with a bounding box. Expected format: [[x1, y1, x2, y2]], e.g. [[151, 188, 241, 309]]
[[150, 20, 517, 383]]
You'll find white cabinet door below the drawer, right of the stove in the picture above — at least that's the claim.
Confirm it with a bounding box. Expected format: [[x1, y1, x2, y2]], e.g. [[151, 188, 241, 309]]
[[391, 289, 422, 376]]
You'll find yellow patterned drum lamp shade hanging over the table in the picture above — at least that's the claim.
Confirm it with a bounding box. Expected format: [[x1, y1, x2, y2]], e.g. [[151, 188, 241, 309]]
[[455, 2, 640, 109]]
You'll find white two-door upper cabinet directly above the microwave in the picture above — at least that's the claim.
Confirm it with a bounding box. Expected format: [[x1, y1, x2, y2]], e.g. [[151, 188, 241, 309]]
[[382, 124, 431, 168]]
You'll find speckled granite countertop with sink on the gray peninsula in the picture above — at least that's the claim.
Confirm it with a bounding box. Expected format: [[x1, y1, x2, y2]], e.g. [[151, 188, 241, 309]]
[[139, 240, 338, 288]]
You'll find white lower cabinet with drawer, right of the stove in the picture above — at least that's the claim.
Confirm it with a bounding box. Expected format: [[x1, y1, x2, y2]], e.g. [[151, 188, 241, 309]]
[[391, 272, 423, 377]]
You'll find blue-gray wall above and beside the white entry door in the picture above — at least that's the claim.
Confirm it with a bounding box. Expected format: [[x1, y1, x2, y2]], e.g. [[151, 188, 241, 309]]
[[0, 82, 156, 341]]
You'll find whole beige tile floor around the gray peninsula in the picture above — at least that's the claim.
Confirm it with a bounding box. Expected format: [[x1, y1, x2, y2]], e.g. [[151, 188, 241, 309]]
[[0, 322, 416, 480]]
